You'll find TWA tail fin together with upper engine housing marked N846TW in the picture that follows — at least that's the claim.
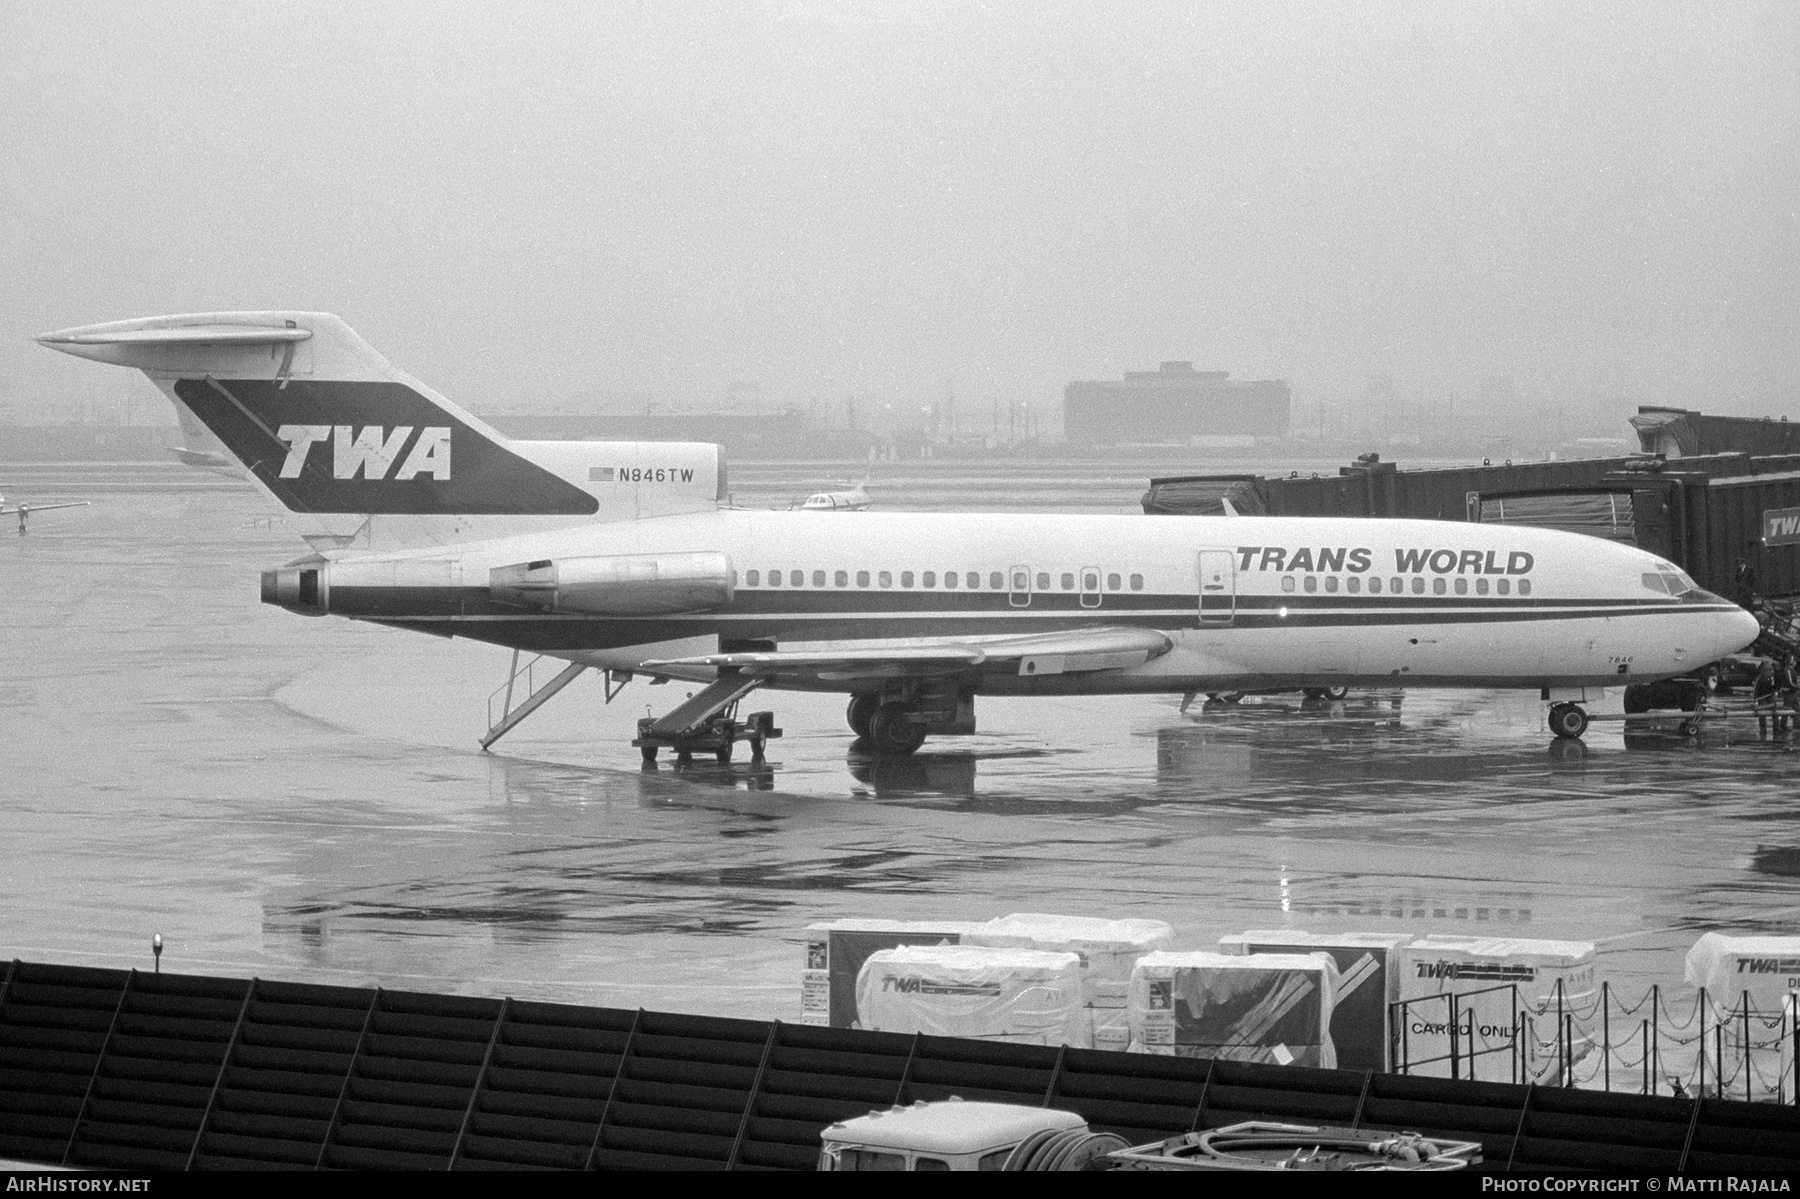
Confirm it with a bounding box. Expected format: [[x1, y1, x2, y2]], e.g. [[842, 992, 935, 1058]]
[[38, 311, 725, 545]]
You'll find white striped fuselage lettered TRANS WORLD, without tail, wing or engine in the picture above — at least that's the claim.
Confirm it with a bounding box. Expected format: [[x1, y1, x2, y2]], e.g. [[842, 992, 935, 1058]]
[[295, 511, 1757, 693]]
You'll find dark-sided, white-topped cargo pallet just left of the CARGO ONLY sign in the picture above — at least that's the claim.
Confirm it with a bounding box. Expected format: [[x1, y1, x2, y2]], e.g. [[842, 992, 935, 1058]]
[[1219, 929, 1413, 1071]]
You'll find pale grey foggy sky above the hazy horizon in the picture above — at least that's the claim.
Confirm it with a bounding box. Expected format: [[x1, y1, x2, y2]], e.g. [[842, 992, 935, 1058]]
[[0, 0, 1800, 424]]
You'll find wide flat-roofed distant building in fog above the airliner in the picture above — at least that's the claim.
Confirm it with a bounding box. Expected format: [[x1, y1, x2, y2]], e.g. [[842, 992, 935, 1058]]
[[1062, 362, 1292, 446]]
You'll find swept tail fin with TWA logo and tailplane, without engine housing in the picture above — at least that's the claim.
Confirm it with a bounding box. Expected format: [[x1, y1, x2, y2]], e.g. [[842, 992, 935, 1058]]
[[38, 311, 599, 517]]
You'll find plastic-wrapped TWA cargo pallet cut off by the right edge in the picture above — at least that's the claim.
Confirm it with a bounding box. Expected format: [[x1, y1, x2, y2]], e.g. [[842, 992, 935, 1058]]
[[1687, 933, 1800, 1102]]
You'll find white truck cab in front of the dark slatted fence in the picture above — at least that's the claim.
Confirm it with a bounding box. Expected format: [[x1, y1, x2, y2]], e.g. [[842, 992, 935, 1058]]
[[819, 1096, 1087, 1170]]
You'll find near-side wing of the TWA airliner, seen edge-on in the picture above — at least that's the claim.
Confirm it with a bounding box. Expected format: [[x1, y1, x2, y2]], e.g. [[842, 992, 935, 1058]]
[[643, 628, 1174, 679]]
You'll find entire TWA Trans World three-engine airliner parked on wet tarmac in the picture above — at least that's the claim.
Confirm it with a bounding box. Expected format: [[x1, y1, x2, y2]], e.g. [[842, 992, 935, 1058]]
[[40, 311, 1757, 753]]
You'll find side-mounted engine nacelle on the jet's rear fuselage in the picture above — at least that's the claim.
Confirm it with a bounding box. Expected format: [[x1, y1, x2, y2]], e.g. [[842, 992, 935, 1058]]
[[488, 549, 733, 616]]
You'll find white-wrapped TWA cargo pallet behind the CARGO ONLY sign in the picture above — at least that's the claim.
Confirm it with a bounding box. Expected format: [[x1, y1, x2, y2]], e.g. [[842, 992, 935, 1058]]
[[1393, 936, 1600, 1086]]
